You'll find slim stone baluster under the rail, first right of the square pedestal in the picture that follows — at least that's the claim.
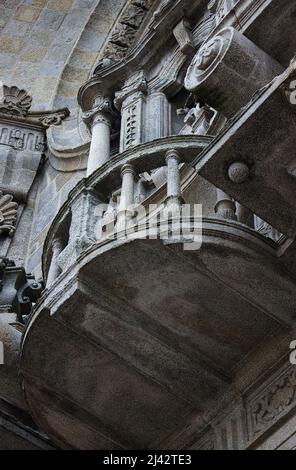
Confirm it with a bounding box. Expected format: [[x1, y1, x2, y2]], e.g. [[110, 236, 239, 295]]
[[117, 163, 135, 230]]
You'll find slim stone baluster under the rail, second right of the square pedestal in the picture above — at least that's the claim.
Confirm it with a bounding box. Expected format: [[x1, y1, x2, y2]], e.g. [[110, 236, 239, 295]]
[[165, 150, 182, 209]]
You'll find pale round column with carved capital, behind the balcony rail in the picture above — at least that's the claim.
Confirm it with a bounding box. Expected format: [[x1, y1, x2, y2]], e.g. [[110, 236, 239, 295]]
[[83, 96, 114, 176]]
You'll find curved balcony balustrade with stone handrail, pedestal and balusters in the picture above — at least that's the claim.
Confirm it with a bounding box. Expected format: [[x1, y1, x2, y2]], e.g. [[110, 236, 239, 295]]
[[44, 136, 212, 286]]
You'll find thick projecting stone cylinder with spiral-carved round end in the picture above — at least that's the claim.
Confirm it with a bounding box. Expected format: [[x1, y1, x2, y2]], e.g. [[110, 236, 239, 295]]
[[185, 27, 283, 118]]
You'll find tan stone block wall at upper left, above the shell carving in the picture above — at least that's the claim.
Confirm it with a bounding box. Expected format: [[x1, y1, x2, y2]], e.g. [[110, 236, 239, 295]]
[[0, 0, 124, 109]]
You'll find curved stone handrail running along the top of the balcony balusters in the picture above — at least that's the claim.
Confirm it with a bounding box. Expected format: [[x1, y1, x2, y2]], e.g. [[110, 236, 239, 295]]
[[43, 135, 212, 278]]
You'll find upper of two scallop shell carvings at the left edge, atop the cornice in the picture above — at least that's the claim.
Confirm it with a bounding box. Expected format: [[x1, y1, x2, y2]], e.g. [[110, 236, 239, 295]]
[[0, 85, 32, 116]]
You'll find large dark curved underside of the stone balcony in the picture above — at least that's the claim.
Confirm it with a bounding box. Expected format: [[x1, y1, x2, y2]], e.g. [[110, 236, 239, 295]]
[[20, 219, 296, 449]]
